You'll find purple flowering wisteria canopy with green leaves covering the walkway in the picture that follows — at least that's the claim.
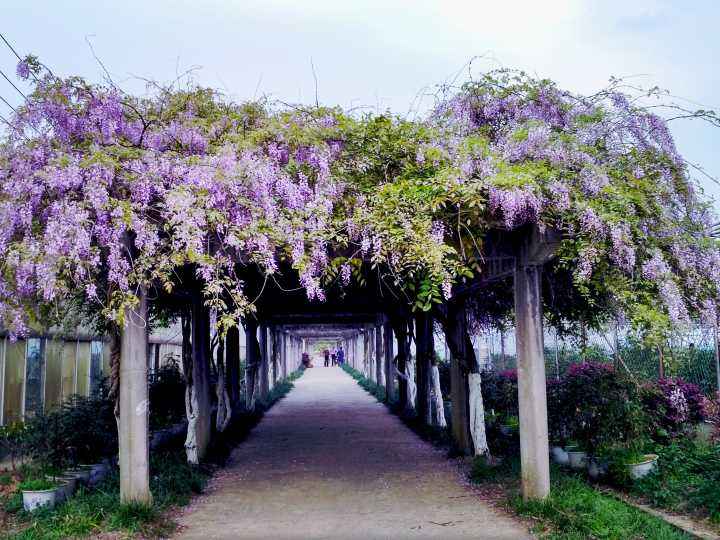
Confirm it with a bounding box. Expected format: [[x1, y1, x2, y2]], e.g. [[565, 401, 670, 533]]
[[0, 57, 720, 339]]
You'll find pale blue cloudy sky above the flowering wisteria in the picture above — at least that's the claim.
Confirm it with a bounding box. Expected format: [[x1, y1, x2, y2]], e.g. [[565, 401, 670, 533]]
[[0, 0, 720, 205]]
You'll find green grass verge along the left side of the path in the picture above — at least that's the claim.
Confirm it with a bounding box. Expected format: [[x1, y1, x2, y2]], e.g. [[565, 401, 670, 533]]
[[0, 371, 302, 540]]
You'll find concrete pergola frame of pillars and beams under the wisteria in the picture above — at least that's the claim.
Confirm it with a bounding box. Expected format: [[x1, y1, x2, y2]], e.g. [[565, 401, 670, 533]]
[[119, 224, 559, 501]]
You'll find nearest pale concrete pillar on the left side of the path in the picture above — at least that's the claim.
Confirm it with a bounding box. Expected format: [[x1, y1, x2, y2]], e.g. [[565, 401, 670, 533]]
[[118, 289, 152, 504]]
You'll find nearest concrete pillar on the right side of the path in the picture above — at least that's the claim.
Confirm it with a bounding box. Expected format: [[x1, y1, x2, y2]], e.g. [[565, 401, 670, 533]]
[[515, 243, 550, 499]]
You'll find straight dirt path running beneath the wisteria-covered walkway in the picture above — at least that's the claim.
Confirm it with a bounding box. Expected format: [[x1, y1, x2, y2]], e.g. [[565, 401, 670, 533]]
[[173, 367, 530, 540]]
